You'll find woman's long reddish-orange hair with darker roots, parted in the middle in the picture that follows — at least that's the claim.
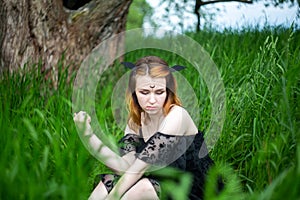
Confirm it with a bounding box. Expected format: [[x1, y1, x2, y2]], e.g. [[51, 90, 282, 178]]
[[126, 56, 181, 132]]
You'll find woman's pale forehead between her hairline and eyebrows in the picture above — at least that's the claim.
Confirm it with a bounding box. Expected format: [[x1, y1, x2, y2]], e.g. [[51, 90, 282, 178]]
[[136, 75, 166, 88]]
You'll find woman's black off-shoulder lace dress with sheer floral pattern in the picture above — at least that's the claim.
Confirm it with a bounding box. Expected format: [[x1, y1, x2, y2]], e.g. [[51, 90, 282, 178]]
[[97, 132, 219, 200]]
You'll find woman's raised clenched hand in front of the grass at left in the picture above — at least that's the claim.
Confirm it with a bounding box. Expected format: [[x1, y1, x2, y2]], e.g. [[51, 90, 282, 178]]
[[73, 111, 93, 136]]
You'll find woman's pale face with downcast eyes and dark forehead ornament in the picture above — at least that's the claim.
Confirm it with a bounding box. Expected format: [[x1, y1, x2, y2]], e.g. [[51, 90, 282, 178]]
[[135, 75, 167, 115]]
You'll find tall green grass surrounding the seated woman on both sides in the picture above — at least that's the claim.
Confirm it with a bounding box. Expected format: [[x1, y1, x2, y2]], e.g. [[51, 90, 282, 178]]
[[0, 25, 300, 199]]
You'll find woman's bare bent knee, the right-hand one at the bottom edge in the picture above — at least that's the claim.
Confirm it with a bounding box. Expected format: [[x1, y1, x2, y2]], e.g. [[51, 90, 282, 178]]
[[121, 178, 159, 200]]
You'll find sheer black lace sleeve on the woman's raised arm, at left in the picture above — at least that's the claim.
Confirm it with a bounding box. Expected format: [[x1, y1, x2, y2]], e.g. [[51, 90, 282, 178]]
[[119, 134, 140, 156]]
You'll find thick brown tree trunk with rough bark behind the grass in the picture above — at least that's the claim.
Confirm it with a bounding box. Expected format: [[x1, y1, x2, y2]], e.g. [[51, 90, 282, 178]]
[[0, 0, 132, 77]]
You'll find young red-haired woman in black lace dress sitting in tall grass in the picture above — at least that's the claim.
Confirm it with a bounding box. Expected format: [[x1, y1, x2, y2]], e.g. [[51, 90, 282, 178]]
[[74, 56, 220, 200]]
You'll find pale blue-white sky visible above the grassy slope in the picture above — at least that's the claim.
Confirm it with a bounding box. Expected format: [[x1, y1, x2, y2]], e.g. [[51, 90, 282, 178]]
[[145, 0, 300, 31]]
